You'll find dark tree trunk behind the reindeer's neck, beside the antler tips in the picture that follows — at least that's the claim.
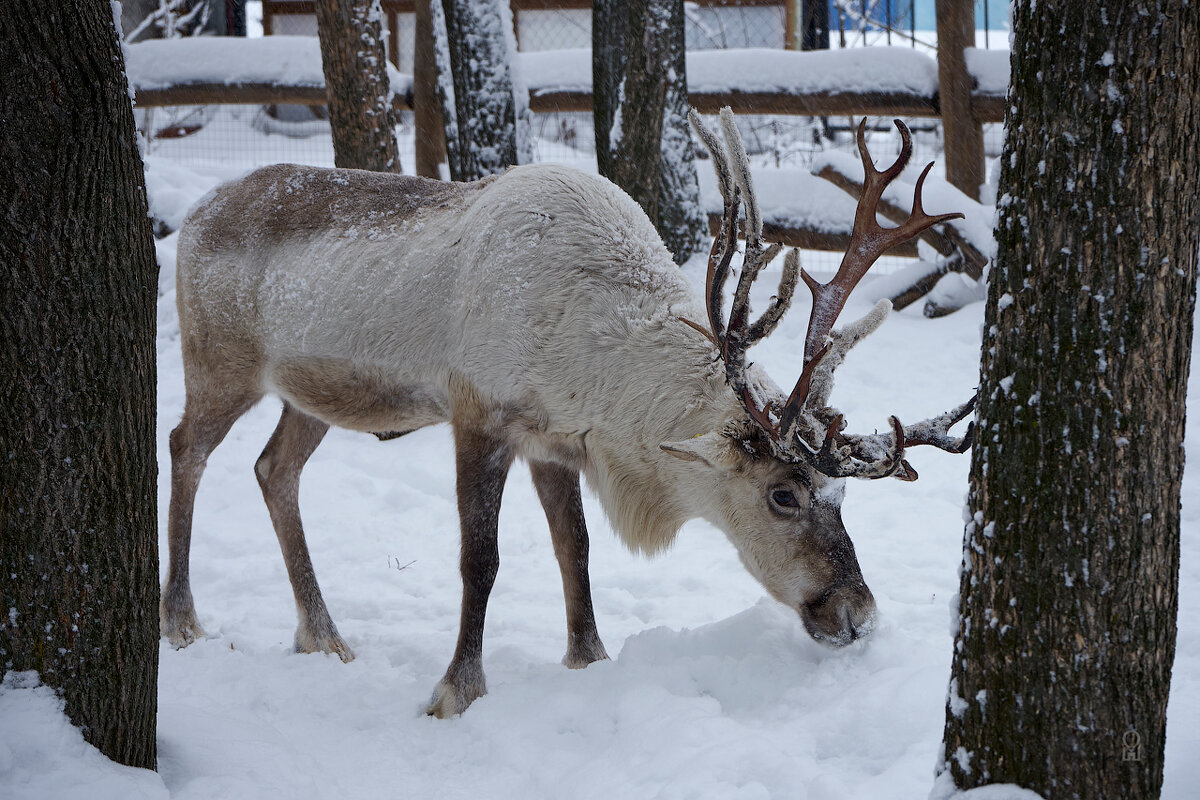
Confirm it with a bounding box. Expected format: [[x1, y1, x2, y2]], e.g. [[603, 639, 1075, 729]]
[[592, 0, 707, 264]]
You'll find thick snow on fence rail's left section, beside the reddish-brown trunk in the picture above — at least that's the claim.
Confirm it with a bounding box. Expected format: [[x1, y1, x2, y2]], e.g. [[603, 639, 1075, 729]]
[[125, 36, 413, 96]]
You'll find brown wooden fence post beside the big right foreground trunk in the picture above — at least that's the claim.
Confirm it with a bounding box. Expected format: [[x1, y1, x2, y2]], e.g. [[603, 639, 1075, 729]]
[[937, 0, 985, 200]]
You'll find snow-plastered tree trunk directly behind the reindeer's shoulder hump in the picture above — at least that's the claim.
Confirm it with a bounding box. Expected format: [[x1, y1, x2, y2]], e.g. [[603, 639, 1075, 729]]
[[434, 0, 523, 181]]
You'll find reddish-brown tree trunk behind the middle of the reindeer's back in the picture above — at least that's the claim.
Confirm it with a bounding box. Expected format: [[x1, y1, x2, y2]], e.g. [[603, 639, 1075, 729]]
[[316, 0, 401, 173]]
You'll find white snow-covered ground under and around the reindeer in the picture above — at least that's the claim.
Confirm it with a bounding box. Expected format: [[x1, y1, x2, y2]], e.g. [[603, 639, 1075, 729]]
[[0, 130, 1200, 800]]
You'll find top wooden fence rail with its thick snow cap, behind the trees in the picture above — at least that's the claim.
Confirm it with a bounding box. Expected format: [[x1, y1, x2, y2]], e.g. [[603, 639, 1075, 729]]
[[125, 36, 1008, 121]]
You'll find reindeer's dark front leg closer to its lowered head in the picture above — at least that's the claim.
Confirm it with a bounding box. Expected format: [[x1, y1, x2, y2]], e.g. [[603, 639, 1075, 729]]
[[529, 461, 608, 669]]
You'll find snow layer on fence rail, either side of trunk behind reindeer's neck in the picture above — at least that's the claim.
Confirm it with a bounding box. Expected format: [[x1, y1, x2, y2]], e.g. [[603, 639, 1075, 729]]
[[517, 47, 937, 97]]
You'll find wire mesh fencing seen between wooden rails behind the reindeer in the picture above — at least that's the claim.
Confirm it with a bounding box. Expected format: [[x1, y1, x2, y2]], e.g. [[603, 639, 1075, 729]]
[[138, 0, 1007, 271]]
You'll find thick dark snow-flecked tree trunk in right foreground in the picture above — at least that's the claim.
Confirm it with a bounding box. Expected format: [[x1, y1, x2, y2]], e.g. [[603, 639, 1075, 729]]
[[938, 0, 1200, 800]]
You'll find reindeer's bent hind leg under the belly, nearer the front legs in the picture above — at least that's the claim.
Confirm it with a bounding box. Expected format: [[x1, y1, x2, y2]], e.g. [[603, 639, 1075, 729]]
[[254, 401, 354, 661]]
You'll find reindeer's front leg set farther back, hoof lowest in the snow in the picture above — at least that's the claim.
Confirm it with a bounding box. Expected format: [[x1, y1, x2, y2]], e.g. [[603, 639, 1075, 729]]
[[425, 421, 512, 720]]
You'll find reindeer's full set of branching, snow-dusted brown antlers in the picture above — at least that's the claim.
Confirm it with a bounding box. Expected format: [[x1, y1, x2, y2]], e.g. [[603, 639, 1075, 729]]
[[689, 108, 974, 480]]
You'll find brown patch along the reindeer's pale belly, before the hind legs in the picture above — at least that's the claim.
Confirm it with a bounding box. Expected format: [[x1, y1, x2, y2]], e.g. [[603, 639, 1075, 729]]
[[268, 356, 450, 433]]
